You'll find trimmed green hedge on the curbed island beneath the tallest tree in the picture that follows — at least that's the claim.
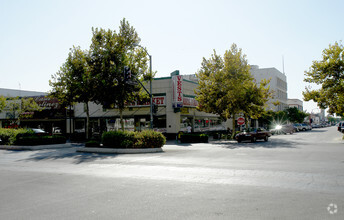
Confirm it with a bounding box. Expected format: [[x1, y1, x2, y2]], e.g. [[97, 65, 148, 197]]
[[102, 130, 166, 148]]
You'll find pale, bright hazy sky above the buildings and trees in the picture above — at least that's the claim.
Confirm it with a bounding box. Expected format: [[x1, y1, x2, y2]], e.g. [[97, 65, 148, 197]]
[[0, 0, 344, 112]]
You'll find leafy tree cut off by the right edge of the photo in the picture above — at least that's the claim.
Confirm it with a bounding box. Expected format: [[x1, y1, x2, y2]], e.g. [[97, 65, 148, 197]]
[[303, 42, 344, 115]]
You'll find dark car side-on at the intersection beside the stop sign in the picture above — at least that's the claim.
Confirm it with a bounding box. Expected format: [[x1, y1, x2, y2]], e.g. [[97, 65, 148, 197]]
[[235, 128, 271, 143]]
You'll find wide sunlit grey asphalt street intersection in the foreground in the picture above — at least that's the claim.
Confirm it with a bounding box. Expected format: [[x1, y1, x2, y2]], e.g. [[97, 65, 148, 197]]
[[0, 127, 344, 219]]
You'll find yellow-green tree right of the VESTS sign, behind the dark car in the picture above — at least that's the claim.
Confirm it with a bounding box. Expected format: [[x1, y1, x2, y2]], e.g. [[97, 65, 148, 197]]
[[196, 44, 270, 131]]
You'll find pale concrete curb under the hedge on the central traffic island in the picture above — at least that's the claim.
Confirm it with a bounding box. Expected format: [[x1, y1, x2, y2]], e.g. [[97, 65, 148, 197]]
[[76, 147, 163, 154]]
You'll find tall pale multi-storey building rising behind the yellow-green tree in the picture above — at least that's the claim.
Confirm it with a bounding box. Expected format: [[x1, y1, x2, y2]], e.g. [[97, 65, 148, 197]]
[[251, 65, 288, 111]]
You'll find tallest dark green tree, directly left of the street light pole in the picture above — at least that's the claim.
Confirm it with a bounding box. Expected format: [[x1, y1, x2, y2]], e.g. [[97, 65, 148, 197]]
[[88, 19, 148, 130]]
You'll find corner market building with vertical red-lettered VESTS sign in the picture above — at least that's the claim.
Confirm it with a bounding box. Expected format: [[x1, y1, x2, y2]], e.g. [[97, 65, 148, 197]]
[[75, 71, 226, 136]]
